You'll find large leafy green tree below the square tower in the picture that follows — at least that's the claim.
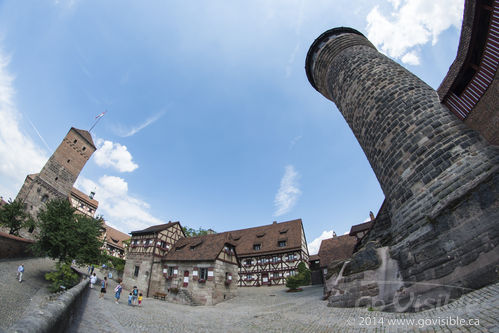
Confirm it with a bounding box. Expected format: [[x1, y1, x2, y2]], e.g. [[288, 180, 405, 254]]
[[34, 199, 103, 264]]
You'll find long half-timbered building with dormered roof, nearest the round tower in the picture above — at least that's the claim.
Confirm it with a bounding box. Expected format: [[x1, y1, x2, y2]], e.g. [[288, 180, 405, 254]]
[[228, 219, 309, 287]]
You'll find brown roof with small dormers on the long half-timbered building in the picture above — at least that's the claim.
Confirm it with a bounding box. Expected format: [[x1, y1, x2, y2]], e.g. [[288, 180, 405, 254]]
[[225, 219, 303, 257]]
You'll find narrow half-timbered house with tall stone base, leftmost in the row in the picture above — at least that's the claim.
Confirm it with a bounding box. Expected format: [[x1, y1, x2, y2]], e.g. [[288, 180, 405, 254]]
[[123, 222, 185, 297]]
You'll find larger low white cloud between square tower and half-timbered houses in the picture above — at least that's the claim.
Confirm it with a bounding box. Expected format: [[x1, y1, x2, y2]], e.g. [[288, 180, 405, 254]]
[[76, 175, 164, 232]]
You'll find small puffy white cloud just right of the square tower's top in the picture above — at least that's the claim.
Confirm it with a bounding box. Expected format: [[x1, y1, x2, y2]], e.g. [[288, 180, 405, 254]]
[[94, 139, 139, 172]]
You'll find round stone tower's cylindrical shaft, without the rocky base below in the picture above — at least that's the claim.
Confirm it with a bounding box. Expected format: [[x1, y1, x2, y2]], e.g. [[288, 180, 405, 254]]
[[305, 27, 498, 239]]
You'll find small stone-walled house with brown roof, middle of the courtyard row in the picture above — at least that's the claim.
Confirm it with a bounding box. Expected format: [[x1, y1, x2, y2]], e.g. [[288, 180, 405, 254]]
[[160, 233, 239, 305]]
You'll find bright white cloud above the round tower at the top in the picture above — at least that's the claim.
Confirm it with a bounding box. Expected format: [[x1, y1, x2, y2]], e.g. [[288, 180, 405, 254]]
[[366, 0, 464, 65]]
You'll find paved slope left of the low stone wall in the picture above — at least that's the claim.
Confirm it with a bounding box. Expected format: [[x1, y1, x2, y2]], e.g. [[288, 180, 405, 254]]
[[0, 258, 55, 330]]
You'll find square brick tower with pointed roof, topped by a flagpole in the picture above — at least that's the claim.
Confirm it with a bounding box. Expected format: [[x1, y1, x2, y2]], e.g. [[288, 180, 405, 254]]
[[16, 127, 96, 231]]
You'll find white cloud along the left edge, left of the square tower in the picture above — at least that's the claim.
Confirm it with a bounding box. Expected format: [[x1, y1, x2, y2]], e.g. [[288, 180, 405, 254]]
[[0, 52, 47, 199]]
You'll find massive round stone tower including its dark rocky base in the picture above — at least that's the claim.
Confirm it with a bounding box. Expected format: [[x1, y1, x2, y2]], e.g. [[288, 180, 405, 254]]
[[306, 27, 499, 310]]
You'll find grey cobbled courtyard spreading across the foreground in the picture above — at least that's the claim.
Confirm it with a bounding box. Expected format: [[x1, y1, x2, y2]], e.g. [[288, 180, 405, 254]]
[[71, 283, 499, 333]]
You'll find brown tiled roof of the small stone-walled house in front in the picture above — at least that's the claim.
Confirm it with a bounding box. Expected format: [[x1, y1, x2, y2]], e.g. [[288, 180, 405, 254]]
[[164, 233, 237, 261]]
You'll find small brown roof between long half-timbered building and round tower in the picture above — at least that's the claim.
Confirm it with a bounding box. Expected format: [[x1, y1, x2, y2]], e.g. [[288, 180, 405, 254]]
[[319, 235, 357, 267]]
